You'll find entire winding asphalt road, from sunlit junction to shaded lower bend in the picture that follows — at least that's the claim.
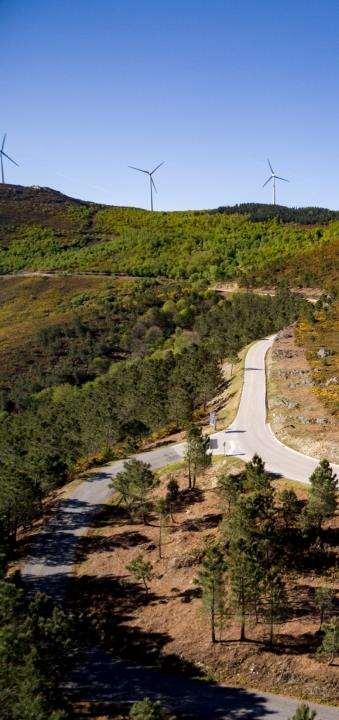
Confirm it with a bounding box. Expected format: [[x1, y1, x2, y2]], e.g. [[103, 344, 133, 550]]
[[22, 336, 339, 720]]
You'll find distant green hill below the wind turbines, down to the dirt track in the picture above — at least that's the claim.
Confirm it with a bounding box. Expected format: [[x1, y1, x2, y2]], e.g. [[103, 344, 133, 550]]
[[0, 185, 339, 284]]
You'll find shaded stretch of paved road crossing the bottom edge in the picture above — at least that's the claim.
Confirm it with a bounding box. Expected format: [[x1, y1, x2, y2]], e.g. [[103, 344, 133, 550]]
[[69, 650, 338, 720]]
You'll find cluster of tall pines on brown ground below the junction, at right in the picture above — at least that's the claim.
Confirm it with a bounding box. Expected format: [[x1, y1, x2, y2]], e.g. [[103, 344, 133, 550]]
[[197, 455, 338, 648]]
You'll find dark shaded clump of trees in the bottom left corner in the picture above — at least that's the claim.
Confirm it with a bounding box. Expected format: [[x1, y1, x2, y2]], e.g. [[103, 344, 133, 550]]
[[0, 580, 75, 720]]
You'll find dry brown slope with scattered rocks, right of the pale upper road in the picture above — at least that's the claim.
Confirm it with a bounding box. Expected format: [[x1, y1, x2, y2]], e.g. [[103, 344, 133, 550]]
[[267, 326, 339, 462]]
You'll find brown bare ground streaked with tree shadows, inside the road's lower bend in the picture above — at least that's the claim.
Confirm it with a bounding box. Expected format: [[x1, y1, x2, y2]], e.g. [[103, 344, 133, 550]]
[[73, 458, 339, 703]]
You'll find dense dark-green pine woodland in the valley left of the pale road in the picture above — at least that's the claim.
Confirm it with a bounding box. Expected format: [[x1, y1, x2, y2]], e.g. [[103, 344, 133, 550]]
[[0, 279, 309, 572]]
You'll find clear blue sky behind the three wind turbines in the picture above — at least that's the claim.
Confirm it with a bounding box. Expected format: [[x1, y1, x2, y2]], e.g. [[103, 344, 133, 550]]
[[0, 0, 339, 209]]
